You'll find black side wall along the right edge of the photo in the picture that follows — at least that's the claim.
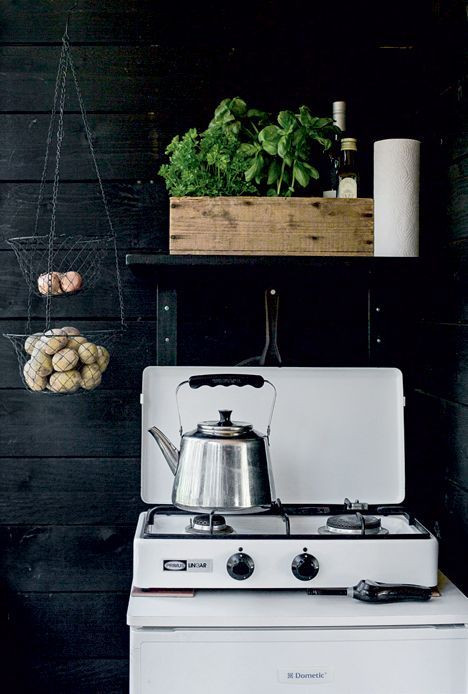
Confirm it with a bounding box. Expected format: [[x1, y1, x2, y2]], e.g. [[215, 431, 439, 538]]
[[411, 7, 468, 592]]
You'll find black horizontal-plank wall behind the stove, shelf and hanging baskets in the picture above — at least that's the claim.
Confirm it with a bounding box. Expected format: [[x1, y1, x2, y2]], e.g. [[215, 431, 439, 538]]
[[0, 0, 467, 694]]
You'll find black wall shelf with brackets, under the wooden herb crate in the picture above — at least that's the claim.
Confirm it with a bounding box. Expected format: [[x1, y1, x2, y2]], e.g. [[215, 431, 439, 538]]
[[126, 251, 424, 366]]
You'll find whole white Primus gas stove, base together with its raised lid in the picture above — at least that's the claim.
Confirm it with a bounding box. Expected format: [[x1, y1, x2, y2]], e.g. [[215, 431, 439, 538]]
[[134, 367, 438, 590]]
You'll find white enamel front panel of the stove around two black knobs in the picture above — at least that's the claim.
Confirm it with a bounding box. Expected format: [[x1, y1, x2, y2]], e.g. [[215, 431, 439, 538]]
[[133, 514, 438, 592]]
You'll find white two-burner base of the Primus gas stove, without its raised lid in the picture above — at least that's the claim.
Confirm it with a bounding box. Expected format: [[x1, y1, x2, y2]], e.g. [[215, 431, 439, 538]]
[[134, 502, 437, 592]]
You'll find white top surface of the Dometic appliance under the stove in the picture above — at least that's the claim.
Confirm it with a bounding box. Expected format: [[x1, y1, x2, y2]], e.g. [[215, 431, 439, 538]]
[[127, 576, 468, 632]]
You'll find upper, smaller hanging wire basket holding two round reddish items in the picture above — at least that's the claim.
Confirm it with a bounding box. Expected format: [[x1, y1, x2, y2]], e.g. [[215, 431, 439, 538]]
[[8, 234, 113, 297]]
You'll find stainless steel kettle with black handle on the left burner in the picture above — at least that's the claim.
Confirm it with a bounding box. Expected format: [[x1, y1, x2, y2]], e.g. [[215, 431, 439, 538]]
[[149, 374, 276, 513]]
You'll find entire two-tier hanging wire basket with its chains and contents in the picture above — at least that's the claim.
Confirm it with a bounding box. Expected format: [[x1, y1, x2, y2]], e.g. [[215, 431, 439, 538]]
[[4, 27, 125, 395]]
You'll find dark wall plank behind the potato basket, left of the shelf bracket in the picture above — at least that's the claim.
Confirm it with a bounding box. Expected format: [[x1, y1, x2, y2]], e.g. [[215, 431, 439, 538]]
[[0, 320, 156, 391]]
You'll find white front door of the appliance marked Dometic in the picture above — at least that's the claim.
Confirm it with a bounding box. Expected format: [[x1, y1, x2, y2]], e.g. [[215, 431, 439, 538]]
[[130, 628, 468, 694]]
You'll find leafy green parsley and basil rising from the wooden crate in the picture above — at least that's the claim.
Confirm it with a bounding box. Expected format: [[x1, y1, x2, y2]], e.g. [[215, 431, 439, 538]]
[[159, 97, 337, 196]]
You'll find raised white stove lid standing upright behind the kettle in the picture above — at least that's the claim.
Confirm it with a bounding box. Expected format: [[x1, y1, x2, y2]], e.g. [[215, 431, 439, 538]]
[[141, 366, 405, 504]]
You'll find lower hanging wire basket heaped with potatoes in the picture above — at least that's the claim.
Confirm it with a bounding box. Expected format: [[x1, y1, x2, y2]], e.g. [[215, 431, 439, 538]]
[[4, 326, 122, 395]]
